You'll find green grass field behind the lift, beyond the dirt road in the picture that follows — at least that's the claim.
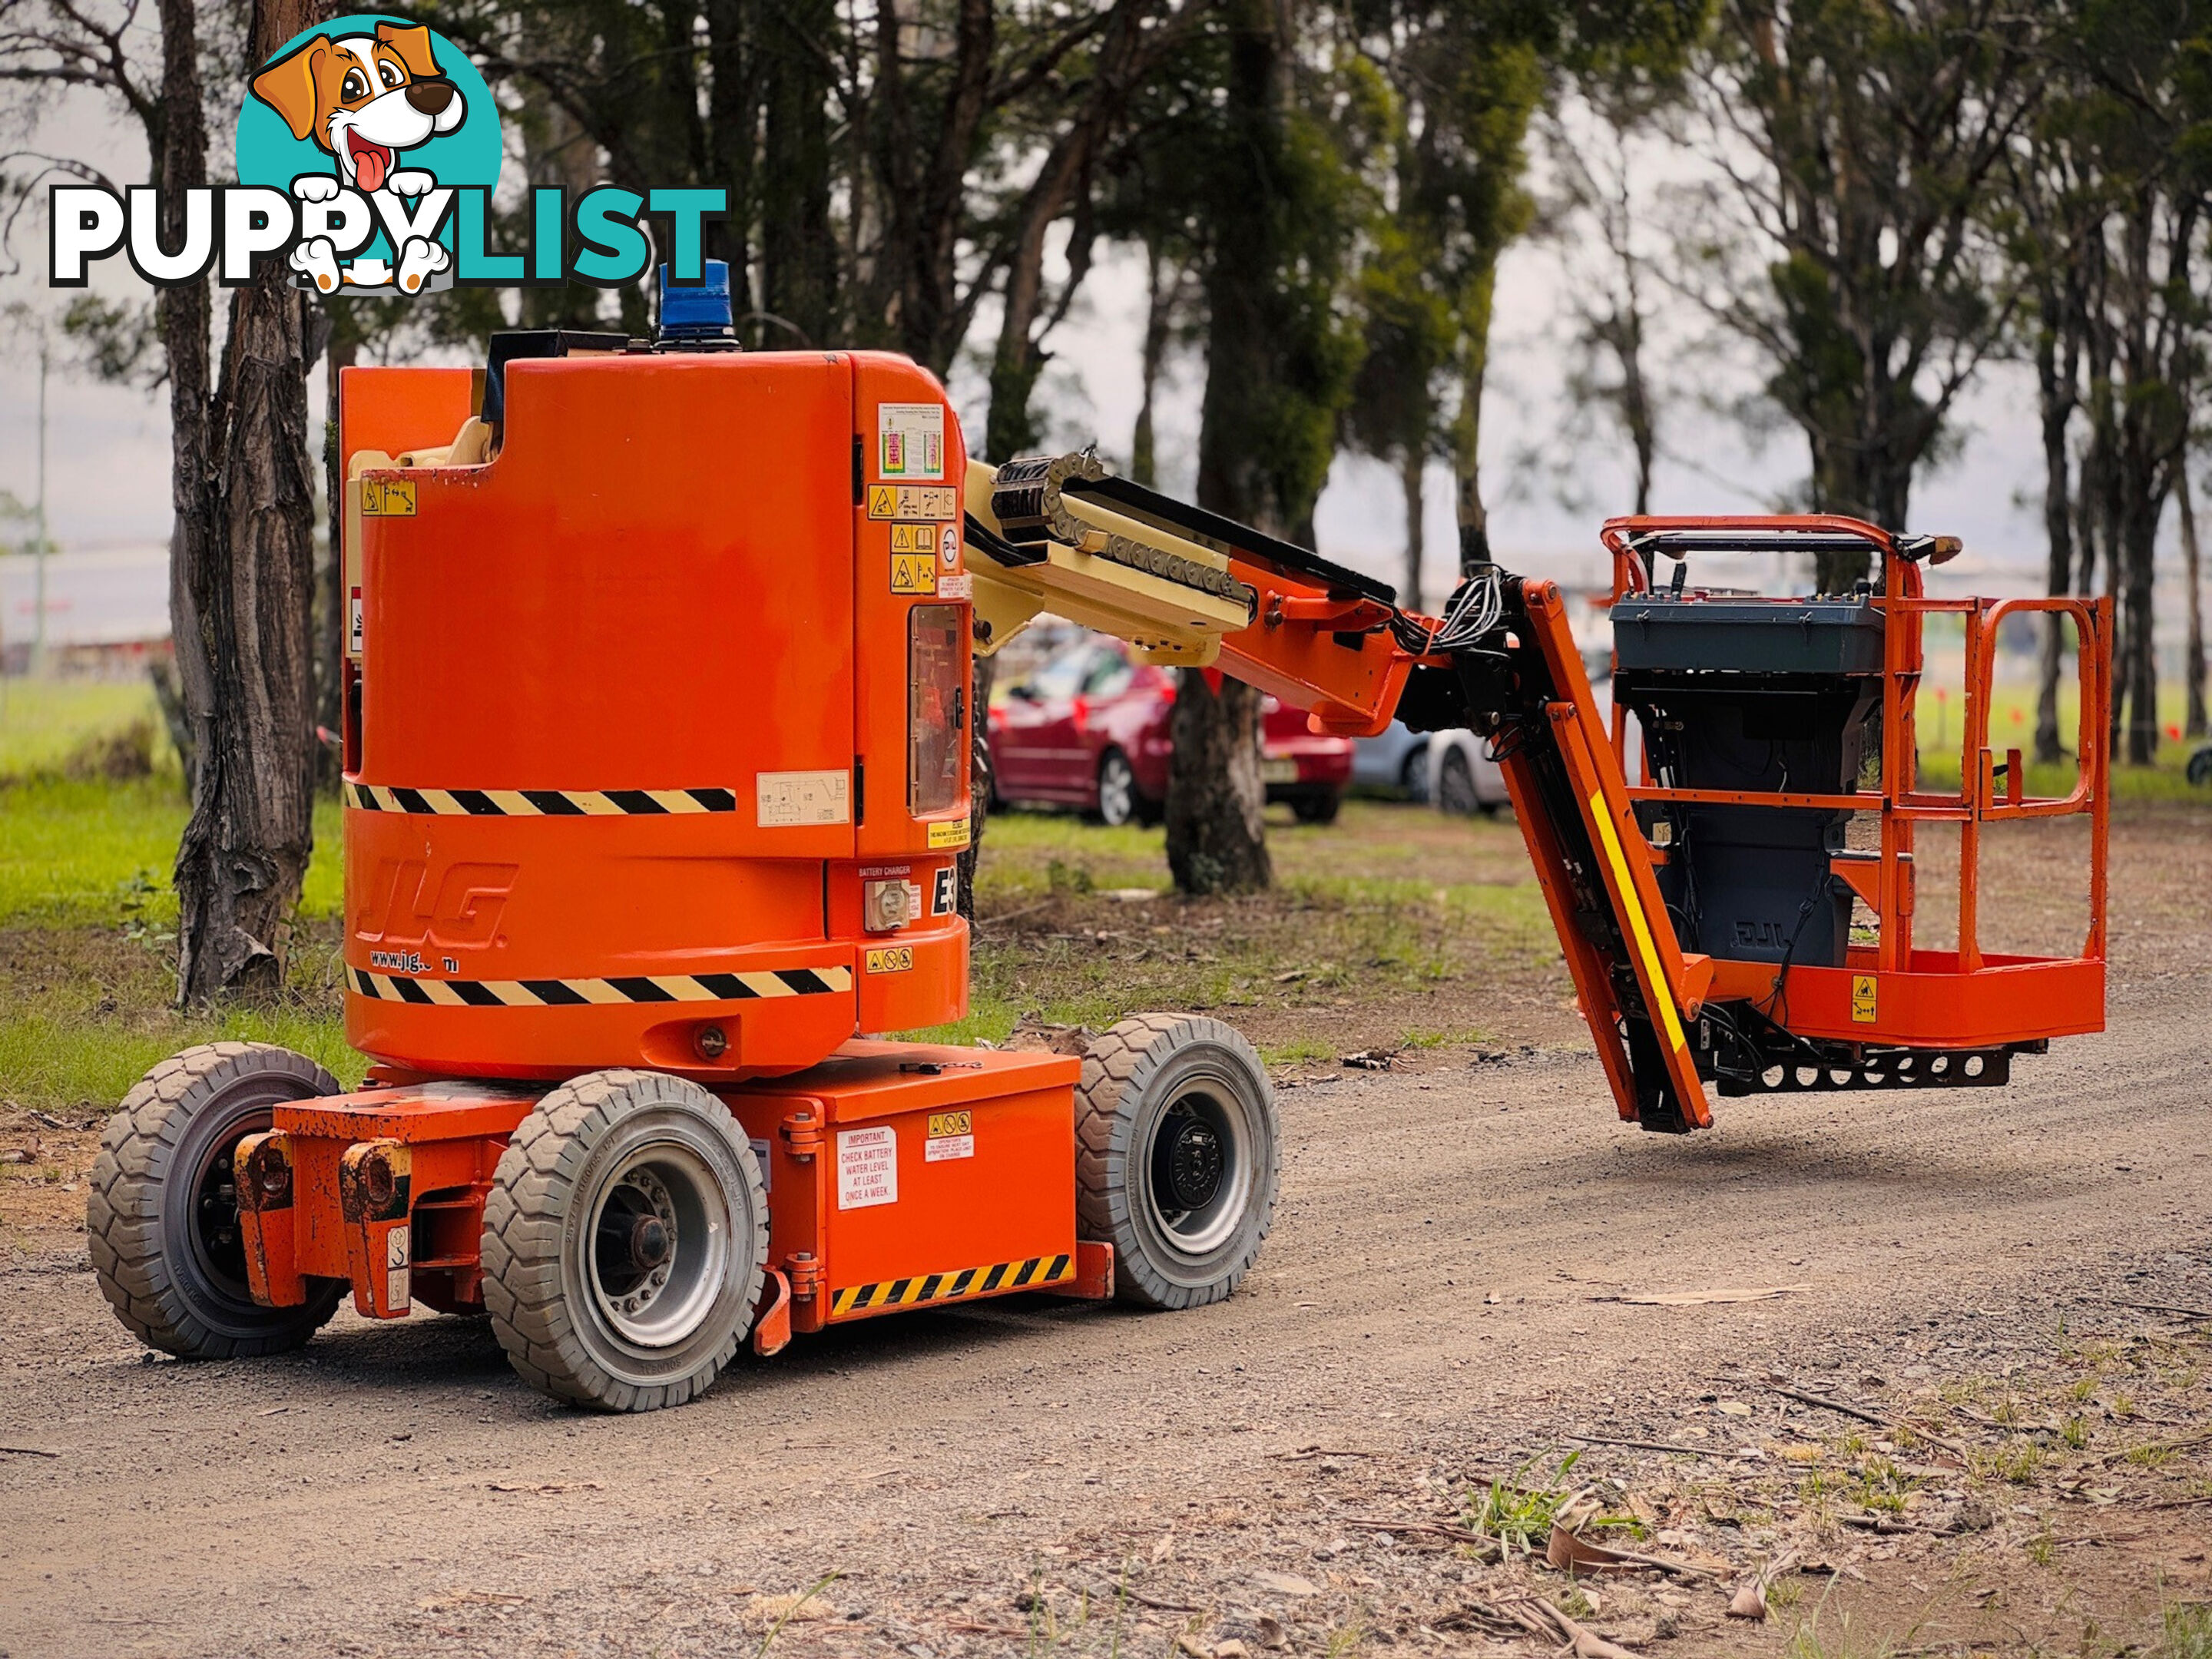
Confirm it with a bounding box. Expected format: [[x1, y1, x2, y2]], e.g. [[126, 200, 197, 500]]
[[0, 681, 2192, 1119]]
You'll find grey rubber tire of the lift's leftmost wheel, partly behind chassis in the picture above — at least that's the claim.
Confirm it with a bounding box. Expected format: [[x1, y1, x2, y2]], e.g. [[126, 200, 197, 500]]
[[84, 1041, 345, 1360]]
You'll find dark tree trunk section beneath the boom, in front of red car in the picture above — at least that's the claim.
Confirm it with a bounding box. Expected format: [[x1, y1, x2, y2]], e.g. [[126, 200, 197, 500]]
[[1168, 668, 1274, 894]]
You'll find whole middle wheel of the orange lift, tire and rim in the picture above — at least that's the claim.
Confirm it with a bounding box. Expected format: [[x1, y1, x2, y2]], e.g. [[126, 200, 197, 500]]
[[485, 1071, 767, 1411]]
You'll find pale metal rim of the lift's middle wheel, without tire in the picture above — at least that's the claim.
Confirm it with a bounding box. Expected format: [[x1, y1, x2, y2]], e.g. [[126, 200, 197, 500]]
[[586, 1144, 730, 1347]]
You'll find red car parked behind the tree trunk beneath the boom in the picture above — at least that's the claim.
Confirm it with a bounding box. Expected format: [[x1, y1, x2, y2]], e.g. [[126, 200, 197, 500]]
[[991, 639, 1352, 823]]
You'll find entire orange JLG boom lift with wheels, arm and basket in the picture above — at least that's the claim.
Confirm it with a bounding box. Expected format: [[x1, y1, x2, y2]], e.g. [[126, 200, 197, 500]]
[[88, 273, 2111, 1409]]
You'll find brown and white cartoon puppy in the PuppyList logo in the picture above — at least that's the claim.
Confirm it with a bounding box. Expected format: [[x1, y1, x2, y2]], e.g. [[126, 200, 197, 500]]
[[254, 22, 469, 294]]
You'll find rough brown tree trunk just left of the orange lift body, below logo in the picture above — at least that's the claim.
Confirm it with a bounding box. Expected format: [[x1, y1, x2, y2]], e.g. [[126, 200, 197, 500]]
[[177, 0, 314, 1005]]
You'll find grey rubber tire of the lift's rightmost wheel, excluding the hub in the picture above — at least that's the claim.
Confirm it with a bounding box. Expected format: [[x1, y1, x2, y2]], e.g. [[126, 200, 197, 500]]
[[1075, 1013, 1283, 1307]]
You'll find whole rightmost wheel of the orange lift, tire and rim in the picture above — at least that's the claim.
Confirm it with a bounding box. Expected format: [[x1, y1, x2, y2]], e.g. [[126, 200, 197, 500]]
[[1075, 1013, 1281, 1307]]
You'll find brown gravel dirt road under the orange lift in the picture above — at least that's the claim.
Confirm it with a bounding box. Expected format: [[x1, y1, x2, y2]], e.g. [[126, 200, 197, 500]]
[[0, 816, 2212, 1659]]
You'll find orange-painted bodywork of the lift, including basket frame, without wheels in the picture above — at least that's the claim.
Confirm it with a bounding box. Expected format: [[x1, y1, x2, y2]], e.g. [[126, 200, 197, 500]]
[[220, 352, 2111, 1354]]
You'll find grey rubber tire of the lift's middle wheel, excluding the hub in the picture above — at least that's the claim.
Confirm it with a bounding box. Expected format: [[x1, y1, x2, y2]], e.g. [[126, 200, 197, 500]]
[[482, 1071, 767, 1411]]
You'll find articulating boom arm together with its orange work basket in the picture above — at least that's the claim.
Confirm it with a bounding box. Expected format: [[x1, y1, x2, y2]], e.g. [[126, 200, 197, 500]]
[[967, 453, 2111, 1133]]
